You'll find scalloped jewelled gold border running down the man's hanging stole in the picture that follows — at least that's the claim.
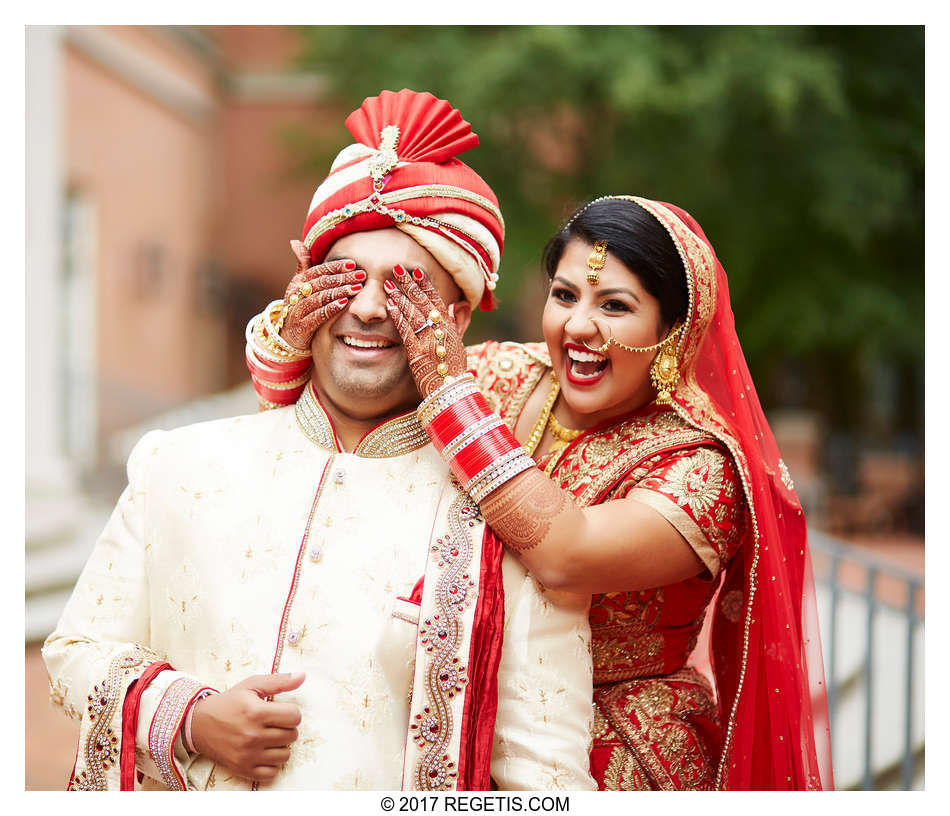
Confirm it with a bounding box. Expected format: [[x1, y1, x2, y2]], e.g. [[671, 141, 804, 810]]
[[410, 492, 478, 790]]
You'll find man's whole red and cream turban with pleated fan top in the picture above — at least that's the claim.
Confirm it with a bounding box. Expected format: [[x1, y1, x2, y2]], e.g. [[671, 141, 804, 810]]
[[302, 89, 505, 310]]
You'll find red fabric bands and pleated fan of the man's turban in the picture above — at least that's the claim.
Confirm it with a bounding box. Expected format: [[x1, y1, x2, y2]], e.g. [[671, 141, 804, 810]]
[[302, 88, 504, 310]]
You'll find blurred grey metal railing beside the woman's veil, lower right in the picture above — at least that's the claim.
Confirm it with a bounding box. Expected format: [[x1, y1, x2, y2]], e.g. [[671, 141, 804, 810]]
[[809, 531, 924, 790]]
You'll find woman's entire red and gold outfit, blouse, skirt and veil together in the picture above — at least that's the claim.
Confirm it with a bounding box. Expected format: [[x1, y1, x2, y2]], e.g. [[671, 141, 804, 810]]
[[469, 196, 833, 790]]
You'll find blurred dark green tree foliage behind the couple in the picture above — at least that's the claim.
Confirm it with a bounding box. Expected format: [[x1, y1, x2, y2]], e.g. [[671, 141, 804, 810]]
[[301, 26, 924, 424]]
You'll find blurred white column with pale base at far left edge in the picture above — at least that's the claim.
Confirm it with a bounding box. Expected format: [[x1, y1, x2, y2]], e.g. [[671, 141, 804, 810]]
[[25, 26, 94, 640]]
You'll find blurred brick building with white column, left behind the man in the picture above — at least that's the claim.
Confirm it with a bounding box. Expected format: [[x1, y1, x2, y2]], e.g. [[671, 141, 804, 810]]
[[26, 26, 345, 638]]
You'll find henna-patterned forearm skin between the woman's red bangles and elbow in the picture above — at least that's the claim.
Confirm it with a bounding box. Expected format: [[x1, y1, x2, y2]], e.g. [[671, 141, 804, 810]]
[[479, 468, 573, 551]]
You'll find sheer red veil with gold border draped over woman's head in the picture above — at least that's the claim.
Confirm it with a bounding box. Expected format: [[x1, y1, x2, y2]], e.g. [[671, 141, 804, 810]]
[[598, 196, 834, 790]]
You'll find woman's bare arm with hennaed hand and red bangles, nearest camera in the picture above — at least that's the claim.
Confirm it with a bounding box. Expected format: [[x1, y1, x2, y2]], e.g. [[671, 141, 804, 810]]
[[387, 270, 740, 593]]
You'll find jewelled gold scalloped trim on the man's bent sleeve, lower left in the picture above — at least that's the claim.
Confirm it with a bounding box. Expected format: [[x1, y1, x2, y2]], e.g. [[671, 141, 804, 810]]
[[69, 648, 158, 791]]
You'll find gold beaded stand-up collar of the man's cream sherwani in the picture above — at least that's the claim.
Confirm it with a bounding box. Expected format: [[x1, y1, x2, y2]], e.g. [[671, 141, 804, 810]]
[[295, 381, 429, 459]]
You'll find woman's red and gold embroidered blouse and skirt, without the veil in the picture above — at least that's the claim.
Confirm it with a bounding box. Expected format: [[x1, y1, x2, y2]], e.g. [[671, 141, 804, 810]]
[[470, 342, 745, 790]]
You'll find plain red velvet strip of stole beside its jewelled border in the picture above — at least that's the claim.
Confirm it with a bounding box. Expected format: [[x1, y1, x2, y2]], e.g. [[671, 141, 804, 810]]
[[458, 527, 505, 790]]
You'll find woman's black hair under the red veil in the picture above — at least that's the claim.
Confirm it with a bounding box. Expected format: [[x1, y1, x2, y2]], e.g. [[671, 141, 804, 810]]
[[541, 198, 689, 327]]
